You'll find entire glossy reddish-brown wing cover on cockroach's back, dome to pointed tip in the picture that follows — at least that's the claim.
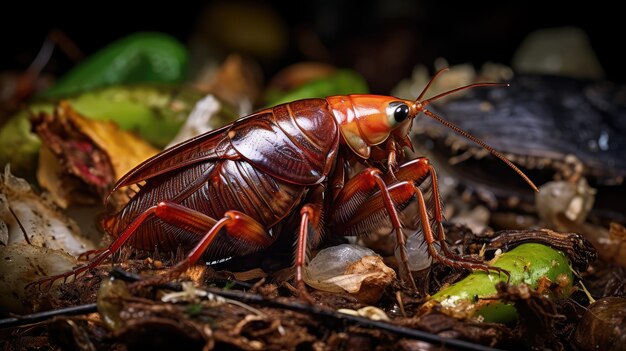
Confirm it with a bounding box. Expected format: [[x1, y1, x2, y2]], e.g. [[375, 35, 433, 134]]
[[111, 99, 339, 192]]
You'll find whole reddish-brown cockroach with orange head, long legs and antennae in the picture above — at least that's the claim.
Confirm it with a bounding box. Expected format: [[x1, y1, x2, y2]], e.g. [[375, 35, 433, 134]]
[[28, 70, 536, 294]]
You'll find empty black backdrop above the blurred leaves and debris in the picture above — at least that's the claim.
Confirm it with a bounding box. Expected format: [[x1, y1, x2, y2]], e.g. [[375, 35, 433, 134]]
[[0, 0, 626, 92]]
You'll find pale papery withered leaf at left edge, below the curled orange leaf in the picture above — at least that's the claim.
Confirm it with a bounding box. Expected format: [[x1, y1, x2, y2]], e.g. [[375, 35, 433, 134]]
[[0, 166, 95, 312]]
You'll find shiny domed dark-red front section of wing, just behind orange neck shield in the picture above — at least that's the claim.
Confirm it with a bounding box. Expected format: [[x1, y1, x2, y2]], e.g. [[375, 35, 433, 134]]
[[228, 99, 339, 185]]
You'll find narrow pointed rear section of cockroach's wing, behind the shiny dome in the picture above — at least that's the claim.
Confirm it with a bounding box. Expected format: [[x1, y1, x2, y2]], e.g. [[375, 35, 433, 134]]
[[111, 125, 237, 193]]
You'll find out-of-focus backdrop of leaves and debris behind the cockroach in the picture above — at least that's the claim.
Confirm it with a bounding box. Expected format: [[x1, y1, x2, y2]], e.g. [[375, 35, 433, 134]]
[[0, 0, 626, 335]]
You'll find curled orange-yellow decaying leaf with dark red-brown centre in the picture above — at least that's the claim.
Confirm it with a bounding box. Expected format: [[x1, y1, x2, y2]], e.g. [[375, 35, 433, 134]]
[[32, 101, 158, 208]]
